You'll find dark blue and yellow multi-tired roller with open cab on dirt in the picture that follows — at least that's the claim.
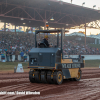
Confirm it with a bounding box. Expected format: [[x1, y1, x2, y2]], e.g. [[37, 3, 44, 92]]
[[28, 30, 84, 84]]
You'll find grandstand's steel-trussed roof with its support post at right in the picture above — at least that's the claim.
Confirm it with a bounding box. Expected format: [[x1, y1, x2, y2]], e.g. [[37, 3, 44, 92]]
[[0, 0, 100, 46]]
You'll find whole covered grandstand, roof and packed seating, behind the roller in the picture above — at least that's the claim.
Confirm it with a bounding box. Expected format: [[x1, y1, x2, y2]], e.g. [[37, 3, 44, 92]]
[[0, 0, 100, 61]]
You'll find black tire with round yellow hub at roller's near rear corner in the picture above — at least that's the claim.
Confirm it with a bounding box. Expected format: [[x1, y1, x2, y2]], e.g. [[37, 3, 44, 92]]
[[53, 71, 63, 85]]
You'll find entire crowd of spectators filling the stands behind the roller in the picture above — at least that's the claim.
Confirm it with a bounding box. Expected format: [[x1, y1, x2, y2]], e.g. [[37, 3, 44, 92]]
[[0, 33, 100, 60]]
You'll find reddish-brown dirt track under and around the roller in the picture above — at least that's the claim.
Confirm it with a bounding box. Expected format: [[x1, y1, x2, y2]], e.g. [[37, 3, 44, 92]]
[[0, 68, 100, 100]]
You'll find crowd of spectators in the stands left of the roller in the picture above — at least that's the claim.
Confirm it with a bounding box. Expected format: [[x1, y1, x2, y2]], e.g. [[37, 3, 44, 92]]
[[0, 33, 34, 61]]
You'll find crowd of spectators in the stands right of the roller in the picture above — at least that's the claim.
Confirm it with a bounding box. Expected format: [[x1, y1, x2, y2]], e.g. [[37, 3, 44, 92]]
[[63, 40, 100, 55]]
